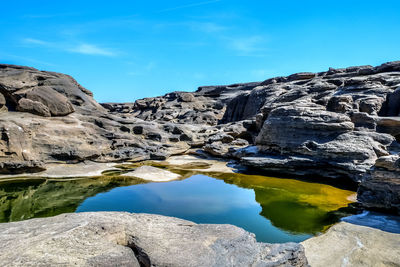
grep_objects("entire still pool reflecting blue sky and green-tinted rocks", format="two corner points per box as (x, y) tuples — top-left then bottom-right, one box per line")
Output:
(0, 173), (354, 245)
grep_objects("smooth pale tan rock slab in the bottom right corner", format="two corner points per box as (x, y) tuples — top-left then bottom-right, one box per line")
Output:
(302, 222), (400, 267)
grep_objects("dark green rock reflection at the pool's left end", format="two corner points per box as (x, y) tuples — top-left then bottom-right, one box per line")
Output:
(0, 177), (140, 222)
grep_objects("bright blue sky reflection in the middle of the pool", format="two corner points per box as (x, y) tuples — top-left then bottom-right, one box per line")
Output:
(76, 175), (309, 242)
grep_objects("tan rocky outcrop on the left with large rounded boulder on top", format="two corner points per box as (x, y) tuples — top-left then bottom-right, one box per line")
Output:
(0, 65), (212, 173)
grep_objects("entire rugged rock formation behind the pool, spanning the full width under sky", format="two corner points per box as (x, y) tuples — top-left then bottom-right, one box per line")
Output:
(0, 61), (400, 212)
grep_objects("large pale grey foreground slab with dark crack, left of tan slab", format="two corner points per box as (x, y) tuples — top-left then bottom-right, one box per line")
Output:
(0, 212), (307, 266)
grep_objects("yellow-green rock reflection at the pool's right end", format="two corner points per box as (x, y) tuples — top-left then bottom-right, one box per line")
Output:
(210, 174), (354, 234)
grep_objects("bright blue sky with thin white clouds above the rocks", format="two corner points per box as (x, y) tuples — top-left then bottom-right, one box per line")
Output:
(0, 0), (400, 102)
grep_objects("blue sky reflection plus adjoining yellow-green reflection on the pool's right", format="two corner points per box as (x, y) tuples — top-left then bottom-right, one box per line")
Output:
(77, 173), (353, 242)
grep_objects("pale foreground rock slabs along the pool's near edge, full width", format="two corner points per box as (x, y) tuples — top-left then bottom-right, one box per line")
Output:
(0, 212), (400, 267)
